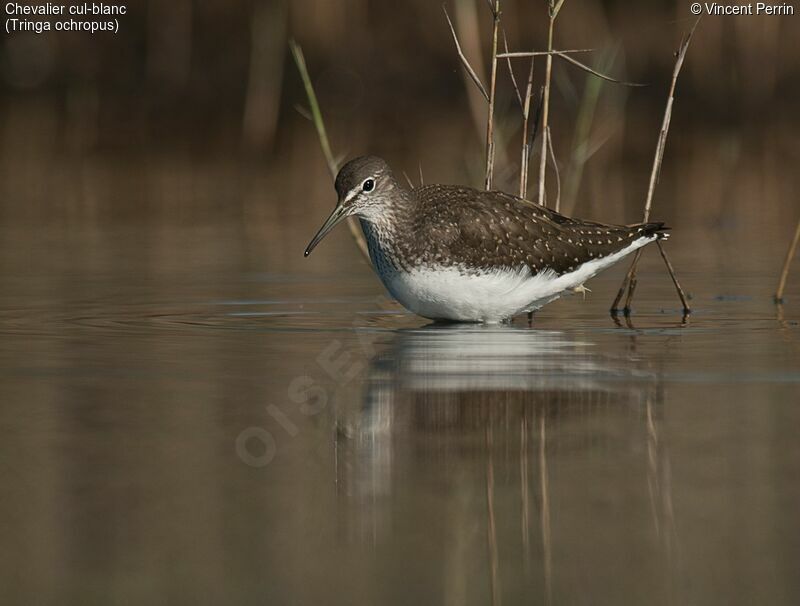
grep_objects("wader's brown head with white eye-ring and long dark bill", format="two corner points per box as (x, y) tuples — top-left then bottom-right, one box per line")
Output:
(305, 156), (400, 257)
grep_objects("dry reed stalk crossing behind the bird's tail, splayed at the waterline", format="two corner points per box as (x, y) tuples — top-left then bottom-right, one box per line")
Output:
(611, 19), (700, 315)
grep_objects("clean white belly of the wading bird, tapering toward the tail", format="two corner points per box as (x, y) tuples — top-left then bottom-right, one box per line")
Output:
(376, 236), (656, 323)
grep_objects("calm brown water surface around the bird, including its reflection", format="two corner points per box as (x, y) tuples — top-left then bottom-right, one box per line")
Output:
(0, 220), (800, 605)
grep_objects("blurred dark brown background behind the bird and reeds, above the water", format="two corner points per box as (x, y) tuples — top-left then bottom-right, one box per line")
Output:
(0, 0), (800, 278)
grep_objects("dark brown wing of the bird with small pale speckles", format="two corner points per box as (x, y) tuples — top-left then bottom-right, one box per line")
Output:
(415, 185), (665, 275)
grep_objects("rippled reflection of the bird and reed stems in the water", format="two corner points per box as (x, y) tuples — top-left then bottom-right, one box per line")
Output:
(335, 325), (669, 603)
